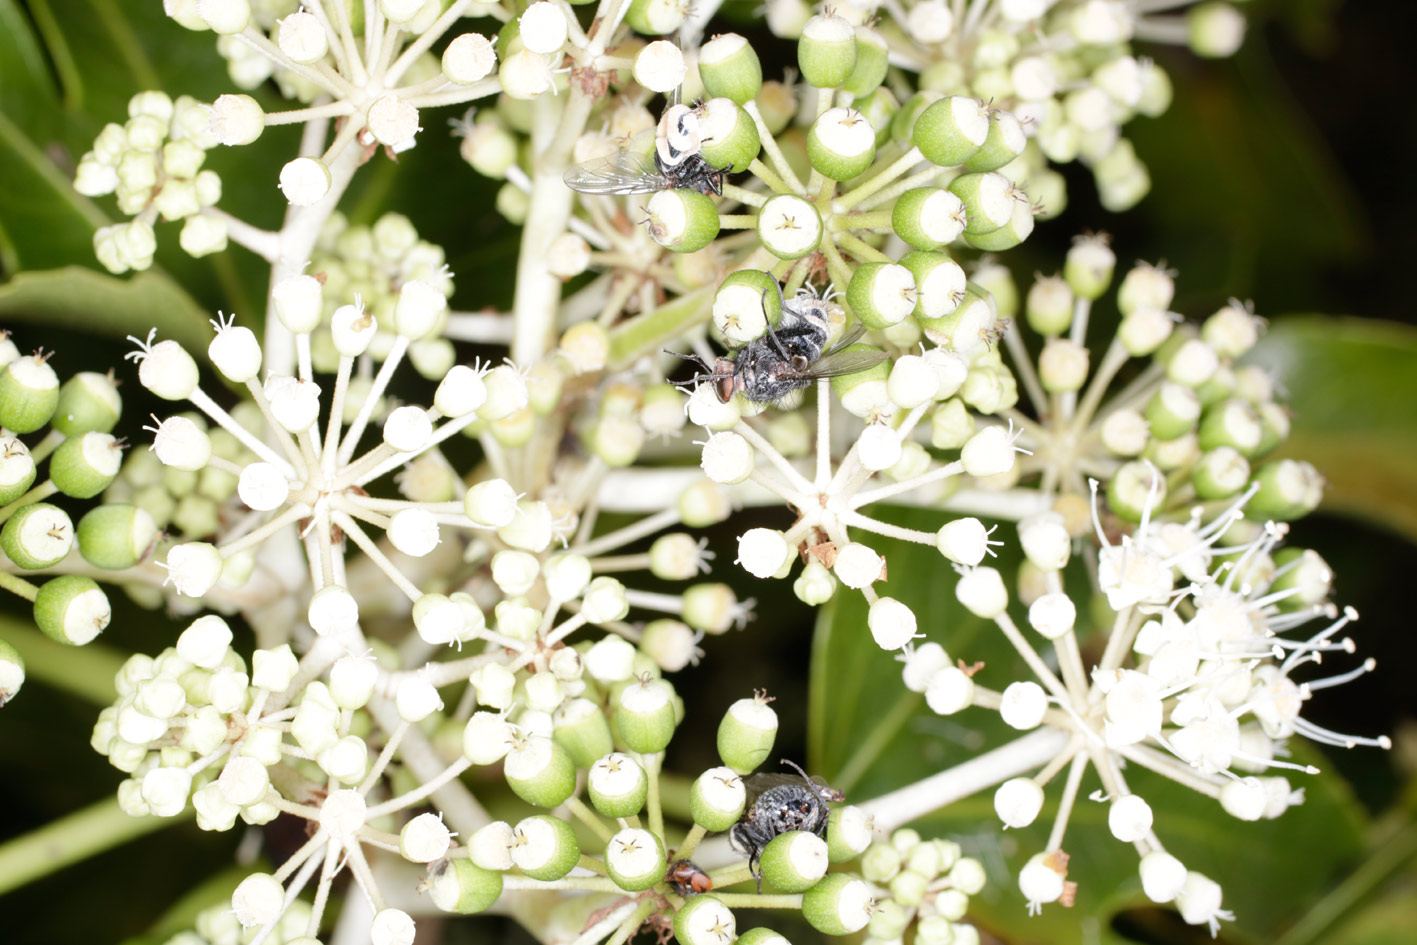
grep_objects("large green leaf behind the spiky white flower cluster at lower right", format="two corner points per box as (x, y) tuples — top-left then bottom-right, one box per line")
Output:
(808, 510), (1363, 945)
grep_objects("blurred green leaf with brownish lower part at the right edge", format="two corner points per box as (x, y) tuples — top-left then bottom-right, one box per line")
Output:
(1250, 316), (1417, 541)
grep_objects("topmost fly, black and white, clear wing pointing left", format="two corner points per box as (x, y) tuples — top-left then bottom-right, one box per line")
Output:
(564, 105), (723, 196)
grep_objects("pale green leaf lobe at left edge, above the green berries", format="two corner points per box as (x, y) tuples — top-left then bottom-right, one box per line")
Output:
(0, 266), (211, 353)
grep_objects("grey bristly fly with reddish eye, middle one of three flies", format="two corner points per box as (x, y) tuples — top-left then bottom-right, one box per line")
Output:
(666, 288), (886, 404)
